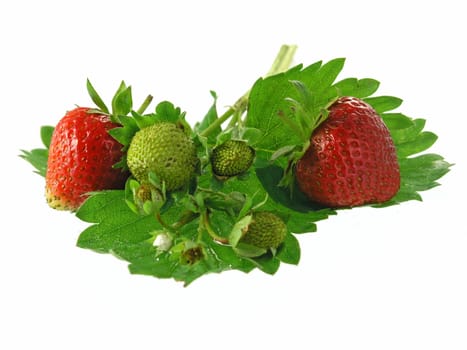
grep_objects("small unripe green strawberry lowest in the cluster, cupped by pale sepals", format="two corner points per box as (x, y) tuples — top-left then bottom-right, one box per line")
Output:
(240, 211), (287, 249)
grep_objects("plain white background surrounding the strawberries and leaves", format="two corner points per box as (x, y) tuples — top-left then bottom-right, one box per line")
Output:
(0, 0), (467, 350)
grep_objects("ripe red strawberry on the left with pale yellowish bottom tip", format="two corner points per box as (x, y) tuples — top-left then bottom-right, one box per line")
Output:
(46, 107), (128, 210)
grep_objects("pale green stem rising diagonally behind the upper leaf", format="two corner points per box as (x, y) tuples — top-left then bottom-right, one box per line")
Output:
(201, 45), (297, 137)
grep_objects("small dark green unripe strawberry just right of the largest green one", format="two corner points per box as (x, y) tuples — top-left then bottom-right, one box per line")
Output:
(211, 140), (255, 177)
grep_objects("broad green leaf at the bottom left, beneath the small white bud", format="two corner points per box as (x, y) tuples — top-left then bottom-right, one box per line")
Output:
(76, 190), (256, 285)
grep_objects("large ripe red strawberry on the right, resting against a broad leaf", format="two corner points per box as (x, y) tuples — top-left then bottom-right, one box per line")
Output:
(295, 97), (400, 207)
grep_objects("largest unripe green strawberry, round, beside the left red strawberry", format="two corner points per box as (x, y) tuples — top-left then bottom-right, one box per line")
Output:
(127, 122), (198, 191)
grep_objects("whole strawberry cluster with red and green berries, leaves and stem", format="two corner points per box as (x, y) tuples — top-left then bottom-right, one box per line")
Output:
(21, 46), (451, 285)
